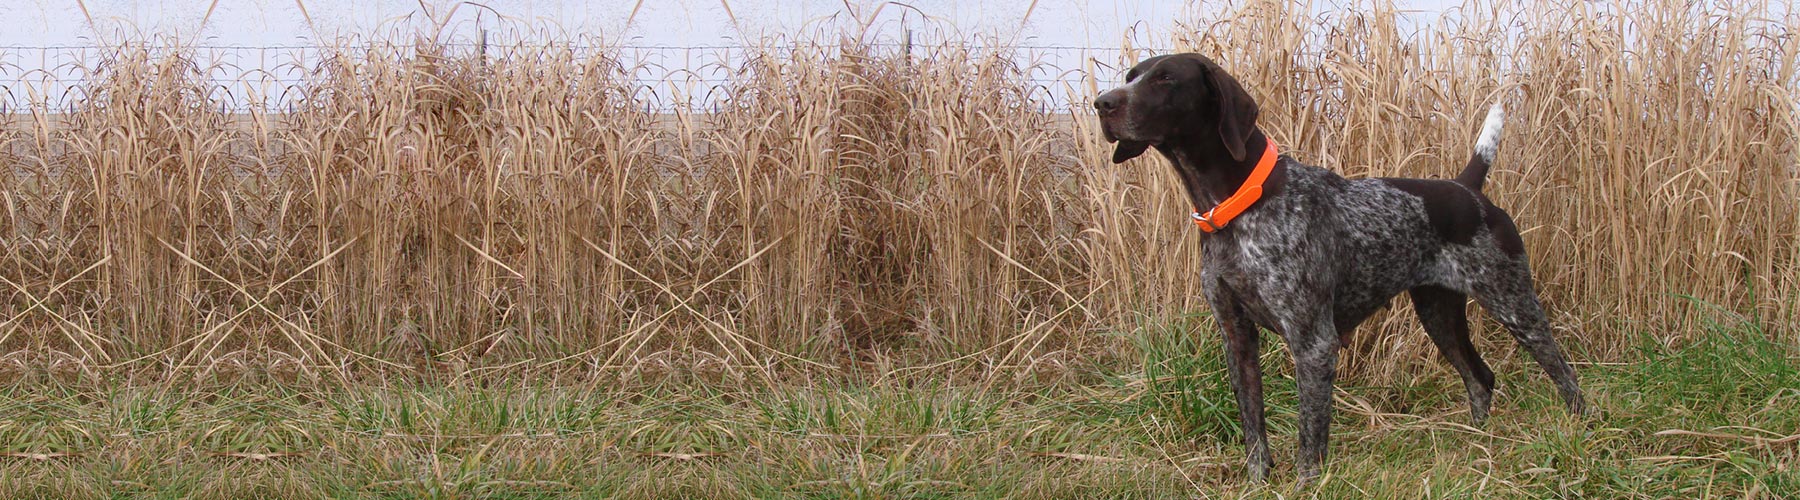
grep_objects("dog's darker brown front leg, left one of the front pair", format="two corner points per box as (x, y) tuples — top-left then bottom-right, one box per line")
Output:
(1213, 299), (1274, 482)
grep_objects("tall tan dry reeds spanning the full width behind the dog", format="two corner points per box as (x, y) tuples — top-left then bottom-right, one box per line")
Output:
(0, 2), (1800, 379)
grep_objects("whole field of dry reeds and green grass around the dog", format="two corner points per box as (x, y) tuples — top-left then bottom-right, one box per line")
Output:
(0, 0), (1800, 498)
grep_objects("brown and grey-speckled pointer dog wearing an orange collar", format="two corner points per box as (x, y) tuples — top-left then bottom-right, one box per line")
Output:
(1094, 54), (1586, 486)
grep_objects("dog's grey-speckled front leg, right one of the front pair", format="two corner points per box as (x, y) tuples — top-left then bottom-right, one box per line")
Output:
(1287, 316), (1339, 486)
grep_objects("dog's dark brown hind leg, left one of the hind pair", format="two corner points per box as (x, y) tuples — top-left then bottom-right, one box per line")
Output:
(1411, 286), (1494, 424)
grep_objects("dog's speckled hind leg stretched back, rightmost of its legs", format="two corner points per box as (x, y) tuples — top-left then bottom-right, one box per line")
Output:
(1471, 255), (1588, 415)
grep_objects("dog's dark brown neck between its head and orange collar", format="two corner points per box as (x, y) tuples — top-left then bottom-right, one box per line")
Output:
(1156, 129), (1285, 212)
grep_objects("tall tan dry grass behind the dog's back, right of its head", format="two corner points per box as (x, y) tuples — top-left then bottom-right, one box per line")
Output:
(1181, 2), (1800, 383)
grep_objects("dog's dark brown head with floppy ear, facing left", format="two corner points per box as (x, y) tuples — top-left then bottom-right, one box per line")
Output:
(1094, 54), (1256, 164)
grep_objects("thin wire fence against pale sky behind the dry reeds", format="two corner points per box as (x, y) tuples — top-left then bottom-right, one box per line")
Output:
(0, 41), (1170, 113)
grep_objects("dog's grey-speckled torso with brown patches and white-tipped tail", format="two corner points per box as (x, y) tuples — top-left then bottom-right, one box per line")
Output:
(1208, 106), (1525, 335)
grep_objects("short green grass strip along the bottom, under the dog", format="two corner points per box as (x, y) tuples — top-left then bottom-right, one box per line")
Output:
(0, 317), (1800, 498)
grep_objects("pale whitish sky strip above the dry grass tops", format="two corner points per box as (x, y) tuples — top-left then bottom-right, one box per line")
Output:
(0, 0), (1462, 106)
